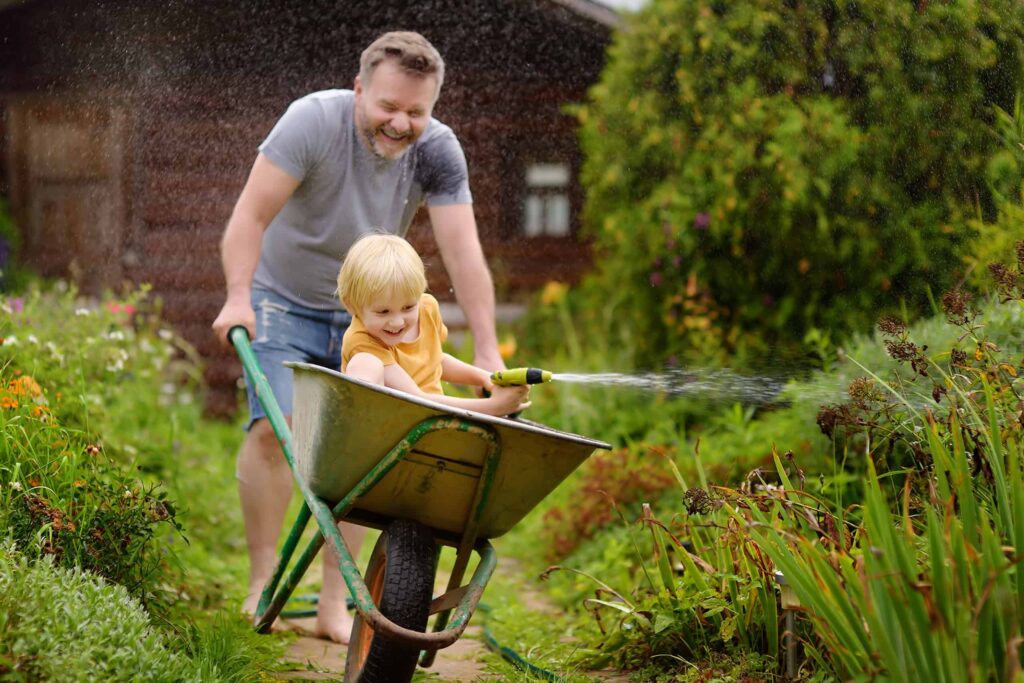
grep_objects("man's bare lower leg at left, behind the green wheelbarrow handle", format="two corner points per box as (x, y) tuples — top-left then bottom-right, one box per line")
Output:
(238, 418), (292, 614)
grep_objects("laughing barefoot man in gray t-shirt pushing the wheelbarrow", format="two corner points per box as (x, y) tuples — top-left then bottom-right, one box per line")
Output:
(213, 32), (504, 643)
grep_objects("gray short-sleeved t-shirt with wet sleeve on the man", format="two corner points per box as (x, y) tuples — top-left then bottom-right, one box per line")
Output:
(253, 90), (473, 310)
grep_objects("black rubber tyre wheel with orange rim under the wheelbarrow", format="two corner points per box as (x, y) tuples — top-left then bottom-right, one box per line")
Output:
(345, 519), (437, 683)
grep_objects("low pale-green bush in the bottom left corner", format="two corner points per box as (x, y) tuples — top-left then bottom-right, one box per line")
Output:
(0, 546), (201, 683)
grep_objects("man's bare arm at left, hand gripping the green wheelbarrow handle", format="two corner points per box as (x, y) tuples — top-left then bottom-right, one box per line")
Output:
(213, 154), (299, 344)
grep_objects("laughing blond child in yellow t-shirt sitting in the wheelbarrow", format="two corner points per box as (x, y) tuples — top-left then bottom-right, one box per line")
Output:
(338, 234), (529, 416)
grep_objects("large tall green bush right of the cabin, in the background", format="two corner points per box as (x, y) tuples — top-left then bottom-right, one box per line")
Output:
(579, 0), (1024, 365)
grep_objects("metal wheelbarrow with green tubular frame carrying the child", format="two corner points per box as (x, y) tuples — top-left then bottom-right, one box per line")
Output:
(228, 327), (610, 683)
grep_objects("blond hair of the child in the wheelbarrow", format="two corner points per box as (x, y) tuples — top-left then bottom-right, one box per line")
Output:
(338, 233), (427, 315)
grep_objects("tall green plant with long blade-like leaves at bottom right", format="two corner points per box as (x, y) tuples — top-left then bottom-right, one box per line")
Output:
(734, 252), (1024, 682)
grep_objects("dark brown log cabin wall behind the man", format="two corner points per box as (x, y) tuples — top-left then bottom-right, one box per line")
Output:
(0, 0), (609, 413)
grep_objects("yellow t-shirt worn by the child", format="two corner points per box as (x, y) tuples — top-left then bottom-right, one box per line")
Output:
(341, 294), (447, 393)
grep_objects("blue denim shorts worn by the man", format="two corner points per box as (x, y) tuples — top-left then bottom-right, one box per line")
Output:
(246, 289), (352, 431)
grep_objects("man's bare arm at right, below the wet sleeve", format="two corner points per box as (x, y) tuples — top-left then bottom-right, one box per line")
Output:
(427, 204), (505, 372)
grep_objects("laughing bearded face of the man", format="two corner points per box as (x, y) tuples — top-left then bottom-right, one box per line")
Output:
(355, 59), (437, 160)
